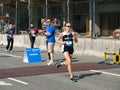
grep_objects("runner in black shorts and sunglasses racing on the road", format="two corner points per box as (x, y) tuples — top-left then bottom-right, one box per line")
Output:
(56, 23), (78, 82)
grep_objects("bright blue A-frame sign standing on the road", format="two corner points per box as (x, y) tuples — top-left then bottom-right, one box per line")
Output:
(23, 48), (42, 63)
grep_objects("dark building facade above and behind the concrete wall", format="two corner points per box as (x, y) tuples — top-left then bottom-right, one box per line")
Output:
(0, 0), (120, 37)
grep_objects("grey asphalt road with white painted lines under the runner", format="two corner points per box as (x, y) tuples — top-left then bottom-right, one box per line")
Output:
(0, 46), (120, 90)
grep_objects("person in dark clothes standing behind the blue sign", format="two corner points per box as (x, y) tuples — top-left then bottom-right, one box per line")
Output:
(27, 22), (38, 48)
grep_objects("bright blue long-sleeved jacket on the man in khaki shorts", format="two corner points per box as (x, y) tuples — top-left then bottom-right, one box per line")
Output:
(46, 25), (55, 42)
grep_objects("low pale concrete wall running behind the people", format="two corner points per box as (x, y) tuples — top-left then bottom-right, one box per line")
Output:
(0, 35), (120, 57)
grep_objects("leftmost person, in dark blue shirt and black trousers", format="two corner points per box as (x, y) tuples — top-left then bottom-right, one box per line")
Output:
(6, 24), (15, 52)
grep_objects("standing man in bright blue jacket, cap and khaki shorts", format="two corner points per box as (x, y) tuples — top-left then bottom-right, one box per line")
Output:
(44, 19), (55, 65)
